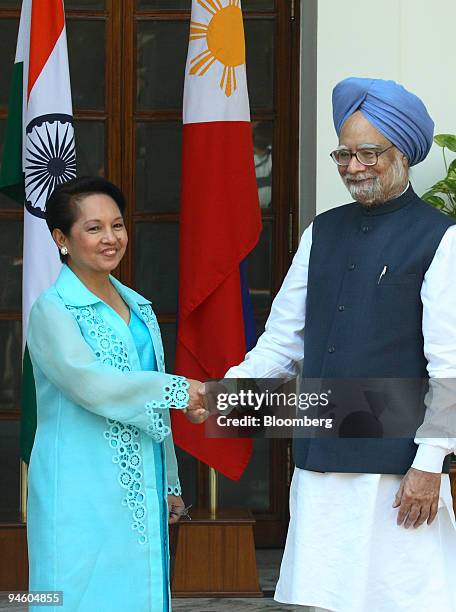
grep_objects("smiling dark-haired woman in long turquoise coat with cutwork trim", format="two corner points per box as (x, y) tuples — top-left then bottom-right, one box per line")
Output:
(27, 177), (204, 612)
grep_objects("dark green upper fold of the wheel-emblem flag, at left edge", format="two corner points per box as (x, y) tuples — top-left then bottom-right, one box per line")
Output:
(0, 62), (25, 204)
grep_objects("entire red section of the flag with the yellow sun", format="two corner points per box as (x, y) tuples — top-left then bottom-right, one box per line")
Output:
(173, 121), (261, 480)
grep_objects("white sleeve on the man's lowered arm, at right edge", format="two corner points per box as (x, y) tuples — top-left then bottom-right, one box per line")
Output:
(412, 226), (456, 473)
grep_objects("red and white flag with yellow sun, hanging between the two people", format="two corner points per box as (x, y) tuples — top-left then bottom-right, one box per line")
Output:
(173, 0), (261, 480)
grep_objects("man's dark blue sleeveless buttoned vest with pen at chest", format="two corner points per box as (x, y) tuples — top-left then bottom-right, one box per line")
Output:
(293, 187), (454, 474)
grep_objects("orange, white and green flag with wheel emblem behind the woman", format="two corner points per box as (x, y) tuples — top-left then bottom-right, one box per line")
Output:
(0, 0), (76, 463)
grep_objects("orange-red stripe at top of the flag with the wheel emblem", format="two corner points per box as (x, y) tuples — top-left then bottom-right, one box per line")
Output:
(27, 0), (65, 99)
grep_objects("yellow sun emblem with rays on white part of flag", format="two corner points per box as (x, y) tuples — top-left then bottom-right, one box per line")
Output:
(190, 0), (245, 97)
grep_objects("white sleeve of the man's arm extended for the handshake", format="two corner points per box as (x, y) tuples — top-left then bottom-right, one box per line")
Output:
(225, 225), (312, 378)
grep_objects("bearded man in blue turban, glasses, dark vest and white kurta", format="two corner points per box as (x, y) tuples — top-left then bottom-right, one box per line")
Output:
(225, 78), (456, 612)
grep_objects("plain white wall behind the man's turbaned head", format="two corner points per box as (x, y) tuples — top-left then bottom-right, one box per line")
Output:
(308, 0), (456, 219)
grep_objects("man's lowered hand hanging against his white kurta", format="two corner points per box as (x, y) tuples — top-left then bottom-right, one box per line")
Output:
(393, 468), (441, 529)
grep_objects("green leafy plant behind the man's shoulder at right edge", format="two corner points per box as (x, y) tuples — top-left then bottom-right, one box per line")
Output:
(422, 134), (456, 219)
